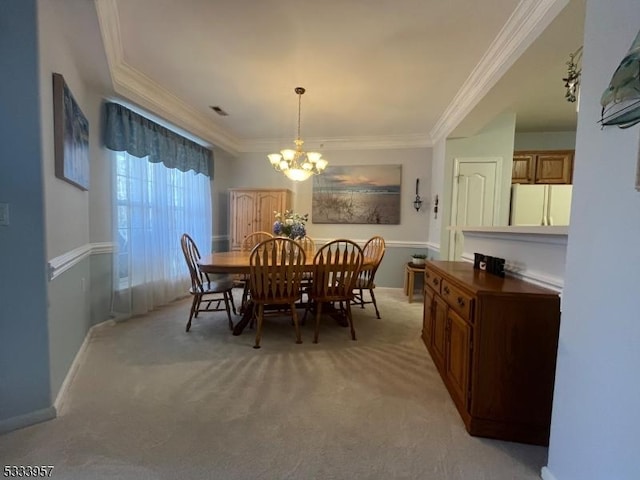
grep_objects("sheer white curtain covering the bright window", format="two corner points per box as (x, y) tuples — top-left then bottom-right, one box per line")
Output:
(112, 152), (211, 318)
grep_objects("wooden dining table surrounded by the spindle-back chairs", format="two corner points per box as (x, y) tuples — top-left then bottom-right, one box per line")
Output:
(198, 250), (375, 335)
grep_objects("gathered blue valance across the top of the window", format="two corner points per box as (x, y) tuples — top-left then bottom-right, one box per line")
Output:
(104, 102), (213, 177)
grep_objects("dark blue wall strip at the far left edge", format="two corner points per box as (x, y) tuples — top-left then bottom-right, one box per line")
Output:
(0, 0), (55, 431)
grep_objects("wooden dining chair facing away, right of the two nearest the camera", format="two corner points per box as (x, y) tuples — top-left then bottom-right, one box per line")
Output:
(305, 239), (364, 343)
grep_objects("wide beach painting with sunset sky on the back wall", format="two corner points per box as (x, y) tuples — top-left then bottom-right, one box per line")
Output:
(311, 165), (402, 225)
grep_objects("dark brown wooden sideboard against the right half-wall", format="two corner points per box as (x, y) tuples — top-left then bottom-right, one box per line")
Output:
(422, 261), (560, 445)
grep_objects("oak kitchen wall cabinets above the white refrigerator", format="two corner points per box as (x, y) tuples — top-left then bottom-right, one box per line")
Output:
(511, 150), (574, 184)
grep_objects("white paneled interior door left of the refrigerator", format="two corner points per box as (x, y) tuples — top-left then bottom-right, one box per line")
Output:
(449, 157), (502, 260)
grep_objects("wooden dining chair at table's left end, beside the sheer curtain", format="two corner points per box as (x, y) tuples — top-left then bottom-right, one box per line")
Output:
(180, 233), (236, 332)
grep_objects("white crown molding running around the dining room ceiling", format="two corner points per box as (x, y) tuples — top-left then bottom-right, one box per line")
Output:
(95, 0), (569, 156)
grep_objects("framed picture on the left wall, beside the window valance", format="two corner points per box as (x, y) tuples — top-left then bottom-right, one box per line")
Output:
(53, 73), (89, 190)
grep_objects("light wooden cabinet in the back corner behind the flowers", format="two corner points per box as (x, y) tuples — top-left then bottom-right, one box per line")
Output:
(229, 188), (291, 250)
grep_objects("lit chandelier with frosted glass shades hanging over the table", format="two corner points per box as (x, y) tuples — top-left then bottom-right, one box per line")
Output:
(267, 87), (329, 182)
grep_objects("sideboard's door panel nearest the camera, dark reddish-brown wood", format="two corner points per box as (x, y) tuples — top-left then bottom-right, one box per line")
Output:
(445, 309), (471, 409)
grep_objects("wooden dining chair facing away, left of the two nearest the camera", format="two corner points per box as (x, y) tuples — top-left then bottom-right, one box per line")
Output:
(249, 237), (306, 348)
